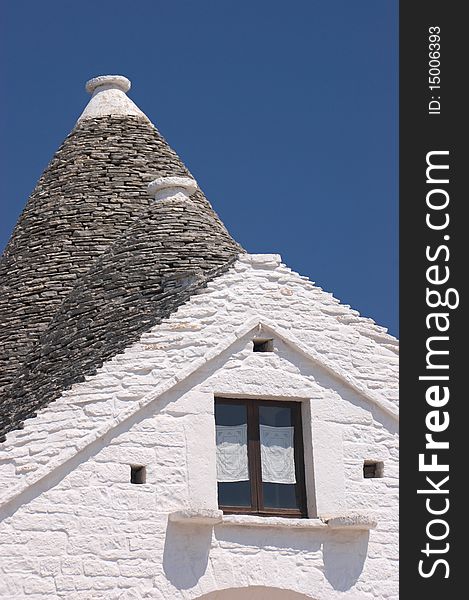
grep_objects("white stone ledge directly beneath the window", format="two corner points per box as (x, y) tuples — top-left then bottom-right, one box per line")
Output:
(169, 509), (376, 531)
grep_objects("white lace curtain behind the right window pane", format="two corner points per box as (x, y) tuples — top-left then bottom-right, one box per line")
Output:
(259, 425), (296, 483)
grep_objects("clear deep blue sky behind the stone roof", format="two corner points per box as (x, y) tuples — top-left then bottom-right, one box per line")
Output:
(0, 0), (398, 335)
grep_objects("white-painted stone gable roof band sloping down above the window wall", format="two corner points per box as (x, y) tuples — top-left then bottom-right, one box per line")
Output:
(0, 255), (397, 516)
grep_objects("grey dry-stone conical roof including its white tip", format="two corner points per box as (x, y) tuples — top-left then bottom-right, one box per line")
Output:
(0, 76), (242, 435)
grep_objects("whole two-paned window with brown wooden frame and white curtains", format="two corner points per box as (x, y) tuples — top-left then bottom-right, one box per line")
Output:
(215, 398), (306, 517)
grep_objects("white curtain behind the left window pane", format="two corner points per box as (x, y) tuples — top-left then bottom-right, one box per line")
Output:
(216, 424), (249, 482)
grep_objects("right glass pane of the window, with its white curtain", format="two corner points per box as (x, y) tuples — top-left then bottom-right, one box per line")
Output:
(259, 405), (298, 508)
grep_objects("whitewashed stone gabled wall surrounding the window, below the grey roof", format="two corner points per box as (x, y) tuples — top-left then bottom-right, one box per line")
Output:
(0, 255), (398, 600)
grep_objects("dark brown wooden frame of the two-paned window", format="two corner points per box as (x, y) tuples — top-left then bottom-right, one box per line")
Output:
(215, 397), (308, 518)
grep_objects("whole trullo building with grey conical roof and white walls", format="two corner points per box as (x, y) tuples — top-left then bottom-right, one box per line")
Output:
(0, 76), (398, 600)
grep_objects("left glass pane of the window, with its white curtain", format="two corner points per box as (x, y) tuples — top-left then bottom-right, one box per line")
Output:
(215, 403), (251, 506)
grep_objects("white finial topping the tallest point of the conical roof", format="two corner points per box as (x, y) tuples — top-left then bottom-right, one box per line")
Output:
(78, 75), (149, 121)
